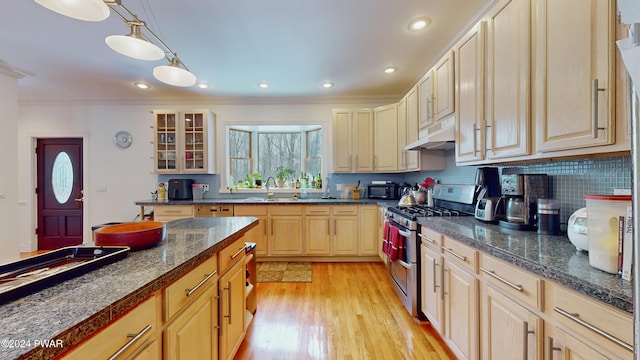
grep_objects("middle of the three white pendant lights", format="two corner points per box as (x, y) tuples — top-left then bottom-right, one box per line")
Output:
(104, 23), (164, 60)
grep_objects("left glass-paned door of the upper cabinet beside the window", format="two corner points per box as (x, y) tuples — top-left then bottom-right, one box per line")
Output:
(153, 110), (180, 173)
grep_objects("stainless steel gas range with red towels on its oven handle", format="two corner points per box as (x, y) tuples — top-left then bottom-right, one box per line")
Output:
(385, 184), (478, 319)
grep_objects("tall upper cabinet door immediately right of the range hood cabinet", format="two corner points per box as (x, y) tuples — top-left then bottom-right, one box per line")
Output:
(454, 22), (485, 163)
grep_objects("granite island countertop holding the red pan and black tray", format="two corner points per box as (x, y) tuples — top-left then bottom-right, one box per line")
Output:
(0, 217), (257, 359)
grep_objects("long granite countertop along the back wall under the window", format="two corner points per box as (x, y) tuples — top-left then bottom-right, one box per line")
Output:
(135, 195), (398, 206)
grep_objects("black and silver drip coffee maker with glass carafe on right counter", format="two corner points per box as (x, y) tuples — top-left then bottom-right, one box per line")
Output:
(498, 174), (549, 230)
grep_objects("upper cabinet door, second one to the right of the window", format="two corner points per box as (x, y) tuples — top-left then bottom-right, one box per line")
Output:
(349, 109), (374, 172)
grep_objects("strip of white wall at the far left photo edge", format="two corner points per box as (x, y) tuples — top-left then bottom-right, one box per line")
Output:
(0, 74), (20, 264)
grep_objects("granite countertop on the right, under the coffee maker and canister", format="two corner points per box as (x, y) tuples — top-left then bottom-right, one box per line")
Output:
(418, 216), (633, 313)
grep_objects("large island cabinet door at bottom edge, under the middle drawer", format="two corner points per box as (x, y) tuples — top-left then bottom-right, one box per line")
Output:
(164, 282), (218, 360)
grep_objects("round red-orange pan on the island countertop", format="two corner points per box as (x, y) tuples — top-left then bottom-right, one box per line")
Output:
(93, 221), (167, 250)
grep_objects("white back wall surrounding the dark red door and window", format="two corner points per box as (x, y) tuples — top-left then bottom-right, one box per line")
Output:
(18, 98), (383, 251)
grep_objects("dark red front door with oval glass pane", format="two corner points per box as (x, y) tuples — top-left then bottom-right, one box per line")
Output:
(36, 138), (84, 250)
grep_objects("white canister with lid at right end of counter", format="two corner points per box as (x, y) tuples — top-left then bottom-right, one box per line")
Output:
(584, 195), (631, 274)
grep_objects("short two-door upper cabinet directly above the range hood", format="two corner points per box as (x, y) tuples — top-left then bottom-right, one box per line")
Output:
(418, 51), (455, 138)
